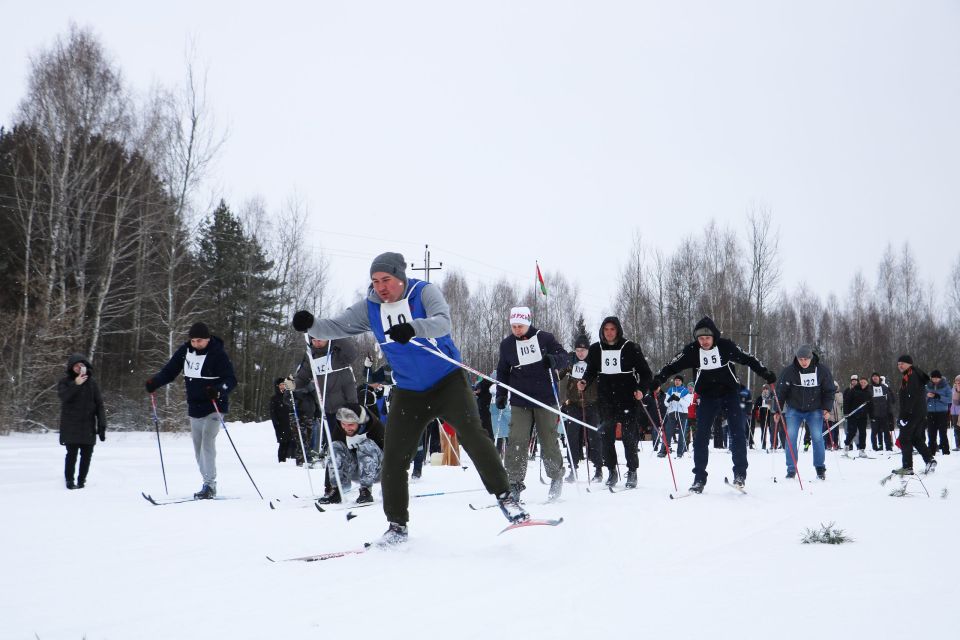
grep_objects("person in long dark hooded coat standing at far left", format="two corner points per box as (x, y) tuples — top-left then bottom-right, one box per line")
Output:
(57, 354), (107, 489)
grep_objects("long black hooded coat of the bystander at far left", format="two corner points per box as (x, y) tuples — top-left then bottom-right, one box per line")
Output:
(57, 355), (107, 445)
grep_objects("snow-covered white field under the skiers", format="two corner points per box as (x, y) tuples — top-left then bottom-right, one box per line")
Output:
(0, 423), (960, 640)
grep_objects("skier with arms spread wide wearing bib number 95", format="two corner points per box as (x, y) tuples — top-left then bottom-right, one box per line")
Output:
(650, 316), (777, 493)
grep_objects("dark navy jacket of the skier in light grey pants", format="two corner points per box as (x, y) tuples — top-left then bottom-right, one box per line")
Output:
(153, 336), (237, 418)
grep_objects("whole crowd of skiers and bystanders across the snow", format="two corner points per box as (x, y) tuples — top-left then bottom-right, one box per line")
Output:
(58, 252), (960, 545)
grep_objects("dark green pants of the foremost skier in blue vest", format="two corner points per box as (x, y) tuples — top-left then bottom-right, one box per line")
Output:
(380, 371), (510, 524)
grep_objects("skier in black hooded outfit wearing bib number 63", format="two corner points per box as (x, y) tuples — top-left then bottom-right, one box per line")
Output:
(577, 316), (650, 489)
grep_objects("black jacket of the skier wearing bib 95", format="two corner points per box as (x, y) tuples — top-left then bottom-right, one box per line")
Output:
(653, 316), (774, 398)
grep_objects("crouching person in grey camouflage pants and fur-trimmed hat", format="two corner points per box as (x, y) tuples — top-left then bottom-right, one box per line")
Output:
(319, 402), (383, 504)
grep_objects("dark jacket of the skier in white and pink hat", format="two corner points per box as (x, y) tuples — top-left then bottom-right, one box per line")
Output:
(496, 325), (567, 407)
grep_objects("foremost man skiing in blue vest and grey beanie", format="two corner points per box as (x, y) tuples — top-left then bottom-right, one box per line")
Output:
(293, 252), (530, 546)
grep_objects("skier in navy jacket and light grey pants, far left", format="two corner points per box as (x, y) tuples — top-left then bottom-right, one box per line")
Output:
(143, 322), (237, 500)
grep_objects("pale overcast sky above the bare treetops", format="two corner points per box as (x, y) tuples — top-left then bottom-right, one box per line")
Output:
(0, 0), (960, 328)
